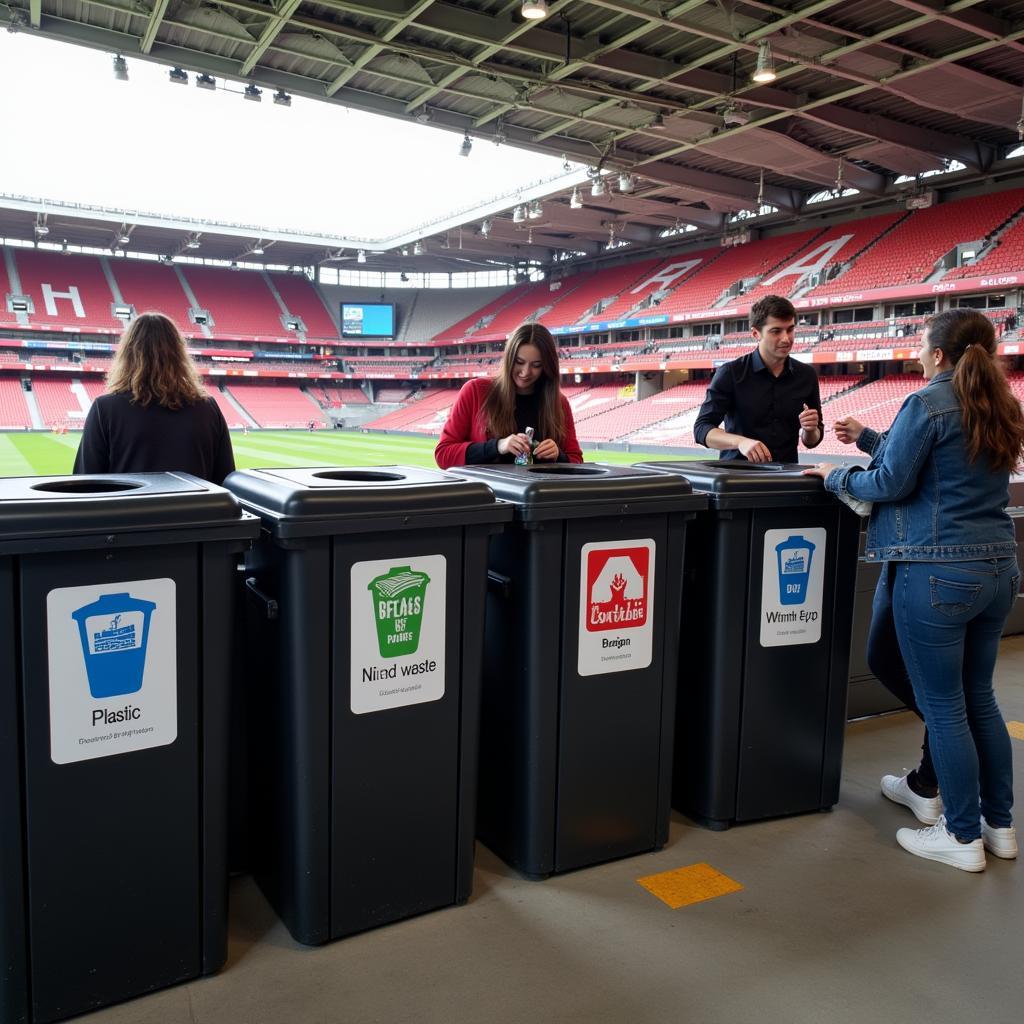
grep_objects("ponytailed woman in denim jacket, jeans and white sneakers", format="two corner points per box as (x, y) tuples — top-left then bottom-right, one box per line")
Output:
(807, 309), (1024, 871)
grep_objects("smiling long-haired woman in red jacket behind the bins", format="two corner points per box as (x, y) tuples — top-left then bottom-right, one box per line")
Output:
(434, 324), (583, 469)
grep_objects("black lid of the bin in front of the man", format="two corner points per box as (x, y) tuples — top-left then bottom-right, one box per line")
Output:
(640, 459), (836, 509)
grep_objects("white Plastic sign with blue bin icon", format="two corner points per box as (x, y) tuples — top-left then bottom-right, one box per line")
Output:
(46, 579), (178, 765)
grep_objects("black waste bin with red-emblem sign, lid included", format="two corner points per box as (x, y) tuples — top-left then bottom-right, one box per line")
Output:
(457, 463), (707, 878)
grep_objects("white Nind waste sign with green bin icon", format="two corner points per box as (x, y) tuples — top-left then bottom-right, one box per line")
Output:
(349, 555), (446, 715)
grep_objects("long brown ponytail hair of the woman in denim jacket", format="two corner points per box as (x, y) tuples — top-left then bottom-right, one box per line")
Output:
(925, 308), (1024, 472)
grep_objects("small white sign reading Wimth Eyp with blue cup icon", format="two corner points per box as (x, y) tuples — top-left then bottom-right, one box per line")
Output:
(761, 526), (827, 647)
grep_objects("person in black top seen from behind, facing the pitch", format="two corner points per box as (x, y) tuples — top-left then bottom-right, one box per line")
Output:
(74, 313), (234, 483)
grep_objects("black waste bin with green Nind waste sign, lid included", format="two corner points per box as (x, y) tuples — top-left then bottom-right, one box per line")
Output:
(225, 466), (511, 944)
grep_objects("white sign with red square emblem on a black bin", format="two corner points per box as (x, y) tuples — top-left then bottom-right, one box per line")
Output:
(578, 540), (654, 676)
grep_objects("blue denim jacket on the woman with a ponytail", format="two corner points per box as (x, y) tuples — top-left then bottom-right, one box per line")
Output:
(825, 371), (1017, 562)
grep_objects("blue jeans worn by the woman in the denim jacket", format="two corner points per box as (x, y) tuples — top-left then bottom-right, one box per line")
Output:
(889, 558), (1020, 841)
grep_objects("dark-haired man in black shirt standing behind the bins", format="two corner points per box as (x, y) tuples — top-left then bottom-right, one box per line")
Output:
(693, 295), (821, 463)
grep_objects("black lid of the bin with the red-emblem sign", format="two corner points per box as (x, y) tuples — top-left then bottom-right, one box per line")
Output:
(452, 462), (708, 522)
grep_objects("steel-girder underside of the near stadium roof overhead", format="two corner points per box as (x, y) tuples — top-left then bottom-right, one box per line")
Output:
(0, 0), (1024, 271)
